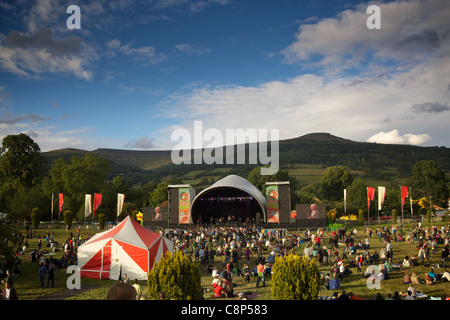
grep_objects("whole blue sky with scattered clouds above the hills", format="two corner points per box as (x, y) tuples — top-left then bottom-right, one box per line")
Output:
(0, 0), (450, 151)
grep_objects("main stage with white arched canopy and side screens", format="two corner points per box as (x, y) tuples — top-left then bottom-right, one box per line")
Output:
(142, 175), (327, 229)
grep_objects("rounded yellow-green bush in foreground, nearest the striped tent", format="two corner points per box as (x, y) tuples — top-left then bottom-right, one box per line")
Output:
(147, 251), (202, 300)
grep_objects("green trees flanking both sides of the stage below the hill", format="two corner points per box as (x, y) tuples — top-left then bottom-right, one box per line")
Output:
(0, 133), (449, 221)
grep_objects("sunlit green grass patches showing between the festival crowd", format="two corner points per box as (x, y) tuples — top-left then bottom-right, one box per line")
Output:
(2, 224), (450, 300)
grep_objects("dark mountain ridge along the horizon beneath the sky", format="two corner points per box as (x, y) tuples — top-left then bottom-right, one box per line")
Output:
(42, 132), (450, 183)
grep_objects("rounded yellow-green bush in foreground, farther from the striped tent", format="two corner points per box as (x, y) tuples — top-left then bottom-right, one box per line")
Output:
(270, 254), (320, 300)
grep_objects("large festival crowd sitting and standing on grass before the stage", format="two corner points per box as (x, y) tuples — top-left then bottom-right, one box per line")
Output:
(0, 220), (450, 300)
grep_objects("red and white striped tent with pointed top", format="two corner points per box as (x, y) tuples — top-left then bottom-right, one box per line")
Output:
(77, 216), (173, 280)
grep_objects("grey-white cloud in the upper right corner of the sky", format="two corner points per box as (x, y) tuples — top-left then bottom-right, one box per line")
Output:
(282, 0), (450, 68)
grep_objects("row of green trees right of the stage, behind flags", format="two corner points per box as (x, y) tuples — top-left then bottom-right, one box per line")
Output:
(297, 160), (449, 217)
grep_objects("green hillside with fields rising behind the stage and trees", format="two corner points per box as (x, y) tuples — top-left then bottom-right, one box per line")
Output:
(43, 133), (450, 188)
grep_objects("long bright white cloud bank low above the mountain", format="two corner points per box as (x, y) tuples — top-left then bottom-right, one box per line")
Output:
(161, 51), (450, 143)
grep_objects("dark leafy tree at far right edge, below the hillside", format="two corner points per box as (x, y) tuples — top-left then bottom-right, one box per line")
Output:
(409, 160), (449, 206)
